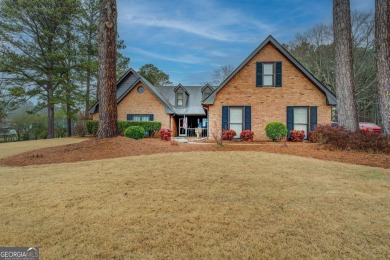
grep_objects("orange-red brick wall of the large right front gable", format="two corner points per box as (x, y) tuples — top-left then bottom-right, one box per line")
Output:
(209, 43), (331, 140)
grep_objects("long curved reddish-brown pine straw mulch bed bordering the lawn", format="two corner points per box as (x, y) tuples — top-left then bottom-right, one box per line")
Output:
(0, 136), (390, 169)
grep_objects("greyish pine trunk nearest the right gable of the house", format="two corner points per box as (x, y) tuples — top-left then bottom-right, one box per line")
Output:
(333, 0), (359, 131)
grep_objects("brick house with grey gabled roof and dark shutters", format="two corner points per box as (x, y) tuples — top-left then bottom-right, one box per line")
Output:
(89, 36), (336, 140)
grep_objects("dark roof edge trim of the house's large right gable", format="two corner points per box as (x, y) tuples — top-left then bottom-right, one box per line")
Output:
(203, 35), (336, 105)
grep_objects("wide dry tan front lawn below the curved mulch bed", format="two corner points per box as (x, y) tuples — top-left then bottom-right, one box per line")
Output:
(0, 152), (390, 259)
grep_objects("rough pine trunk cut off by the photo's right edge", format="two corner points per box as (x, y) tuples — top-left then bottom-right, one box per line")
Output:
(375, 0), (390, 136)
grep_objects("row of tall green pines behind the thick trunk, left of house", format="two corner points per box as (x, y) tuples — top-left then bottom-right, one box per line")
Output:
(0, 0), (130, 138)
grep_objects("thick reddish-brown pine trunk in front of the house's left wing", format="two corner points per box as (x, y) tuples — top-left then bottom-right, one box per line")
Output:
(96, 0), (118, 139)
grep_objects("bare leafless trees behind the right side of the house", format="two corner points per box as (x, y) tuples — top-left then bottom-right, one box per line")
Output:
(284, 9), (381, 123)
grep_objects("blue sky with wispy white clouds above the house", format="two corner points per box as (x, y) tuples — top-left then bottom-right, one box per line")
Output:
(117, 0), (374, 85)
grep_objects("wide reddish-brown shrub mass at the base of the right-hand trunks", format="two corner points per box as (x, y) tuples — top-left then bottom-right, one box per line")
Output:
(310, 125), (390, 154)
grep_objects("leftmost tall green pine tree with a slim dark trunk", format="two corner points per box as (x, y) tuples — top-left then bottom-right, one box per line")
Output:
(0, 0), (78, 138)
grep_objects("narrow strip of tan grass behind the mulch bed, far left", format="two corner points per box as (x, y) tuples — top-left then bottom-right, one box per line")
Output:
(0, 137), (88, 159)
